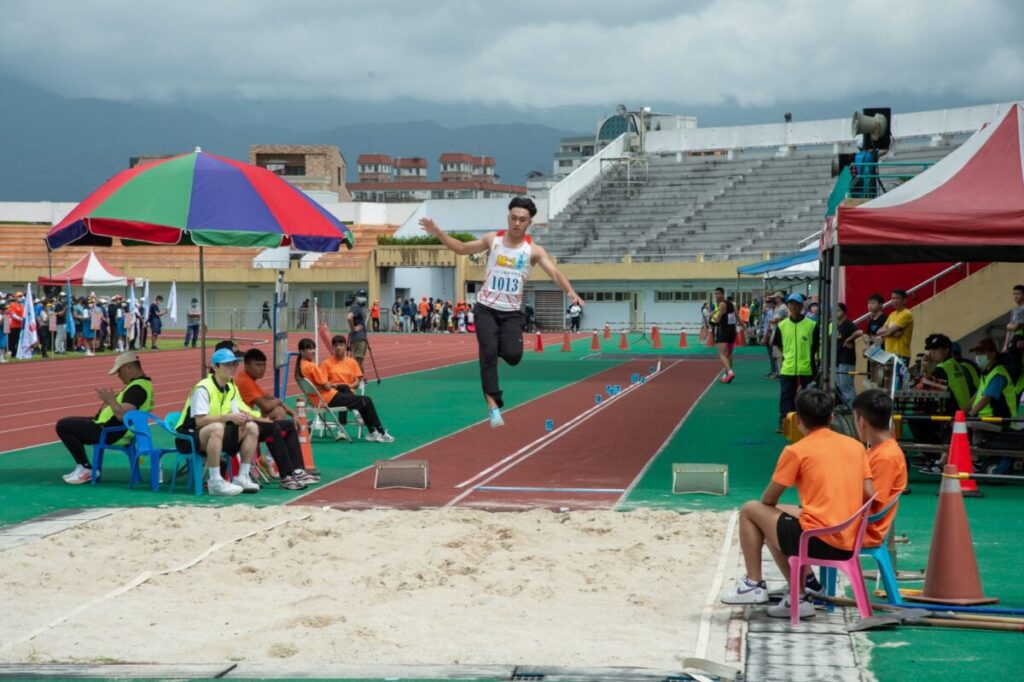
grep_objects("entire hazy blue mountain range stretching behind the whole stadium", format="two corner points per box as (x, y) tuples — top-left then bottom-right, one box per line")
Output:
(0, 74), (995, 202)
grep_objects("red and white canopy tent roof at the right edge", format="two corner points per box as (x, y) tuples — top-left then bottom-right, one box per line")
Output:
(821, 103), (1024, 265)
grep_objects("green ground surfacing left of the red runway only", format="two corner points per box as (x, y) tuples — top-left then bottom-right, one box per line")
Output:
(0, 342), (615, 524)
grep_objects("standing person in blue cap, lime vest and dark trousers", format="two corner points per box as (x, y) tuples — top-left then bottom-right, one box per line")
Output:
(772, 294), (820, 433)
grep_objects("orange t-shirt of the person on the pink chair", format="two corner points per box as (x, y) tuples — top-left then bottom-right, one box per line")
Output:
(771, 428), (871, 550)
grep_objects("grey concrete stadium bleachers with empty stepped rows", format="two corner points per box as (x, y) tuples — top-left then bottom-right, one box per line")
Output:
(537, 141), (954, 263)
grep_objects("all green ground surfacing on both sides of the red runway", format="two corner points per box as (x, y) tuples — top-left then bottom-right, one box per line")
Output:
(0, 346), (1024, 681)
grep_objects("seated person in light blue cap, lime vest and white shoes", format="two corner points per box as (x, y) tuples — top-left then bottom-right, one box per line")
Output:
(175, 348), (259, 497)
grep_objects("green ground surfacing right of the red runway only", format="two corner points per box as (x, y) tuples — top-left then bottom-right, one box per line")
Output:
(623, 361), (1024, 682)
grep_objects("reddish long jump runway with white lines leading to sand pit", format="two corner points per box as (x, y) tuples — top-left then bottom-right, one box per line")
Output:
(292, 360), (721, 510)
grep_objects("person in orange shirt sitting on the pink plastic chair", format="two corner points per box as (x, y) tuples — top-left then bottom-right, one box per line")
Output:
(721, 388), (874, 617)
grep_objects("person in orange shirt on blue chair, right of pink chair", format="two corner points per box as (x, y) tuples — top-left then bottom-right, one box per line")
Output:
(853, 388), (906, 547)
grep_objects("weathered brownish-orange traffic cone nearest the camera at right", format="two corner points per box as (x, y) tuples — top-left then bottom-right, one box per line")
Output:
(905, 464), (998, 605)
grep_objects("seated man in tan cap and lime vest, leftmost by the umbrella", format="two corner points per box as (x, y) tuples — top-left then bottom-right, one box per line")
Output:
(56, 352), (153, 485)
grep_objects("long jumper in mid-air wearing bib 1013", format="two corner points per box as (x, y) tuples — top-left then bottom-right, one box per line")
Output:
(420, 197), (584, 427)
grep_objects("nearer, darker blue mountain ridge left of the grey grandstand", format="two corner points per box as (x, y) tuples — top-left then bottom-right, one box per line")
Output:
(0, 76), (579, 202)
